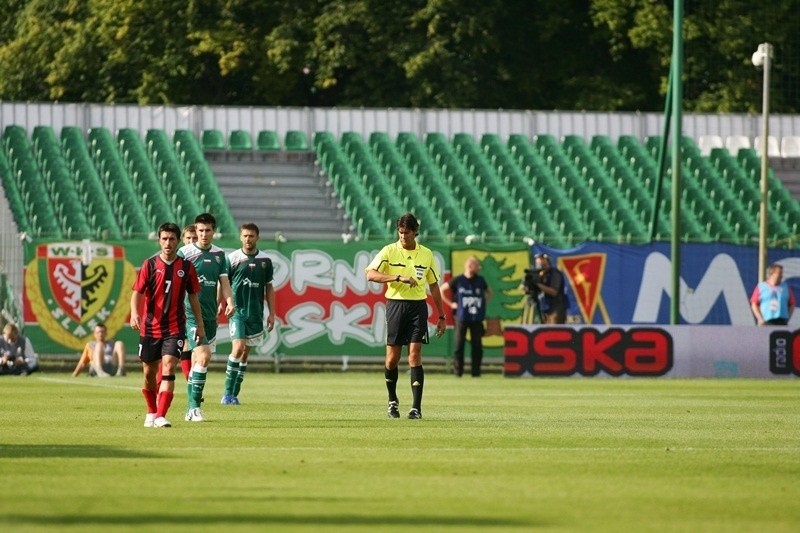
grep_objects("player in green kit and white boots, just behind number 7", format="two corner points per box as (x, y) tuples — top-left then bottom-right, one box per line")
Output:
(178, 213), (235, 422)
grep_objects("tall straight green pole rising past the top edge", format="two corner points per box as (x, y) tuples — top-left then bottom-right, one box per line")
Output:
(669, 0), (683, 325)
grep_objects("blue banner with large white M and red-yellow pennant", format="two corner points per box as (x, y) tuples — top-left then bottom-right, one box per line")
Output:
(532, 243), (800, 329)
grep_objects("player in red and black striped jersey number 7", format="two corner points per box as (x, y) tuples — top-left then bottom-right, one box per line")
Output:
(131, 222), (205, 428)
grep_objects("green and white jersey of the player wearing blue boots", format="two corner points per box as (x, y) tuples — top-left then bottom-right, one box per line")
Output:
(228, 248), (273, 321)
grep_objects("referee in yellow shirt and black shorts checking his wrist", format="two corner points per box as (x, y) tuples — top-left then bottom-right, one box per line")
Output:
(364, 213), (445, 419)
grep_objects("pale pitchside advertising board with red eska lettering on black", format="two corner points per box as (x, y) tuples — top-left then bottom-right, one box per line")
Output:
(503, 325), (800, 378)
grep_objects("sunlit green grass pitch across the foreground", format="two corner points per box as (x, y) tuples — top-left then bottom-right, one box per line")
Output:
(0, 369), (800, 532)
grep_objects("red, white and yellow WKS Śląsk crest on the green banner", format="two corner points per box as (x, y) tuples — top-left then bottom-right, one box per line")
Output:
(25, 241), (136, 350)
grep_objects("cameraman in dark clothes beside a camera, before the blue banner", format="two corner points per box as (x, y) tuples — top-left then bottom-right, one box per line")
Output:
(522, 254), (567, 324)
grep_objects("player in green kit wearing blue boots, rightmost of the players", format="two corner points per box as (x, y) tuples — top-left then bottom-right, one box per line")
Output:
(221, 223), (275, 405)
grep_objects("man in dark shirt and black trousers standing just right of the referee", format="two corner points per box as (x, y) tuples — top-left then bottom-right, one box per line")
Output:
(440, 256), (492, 377)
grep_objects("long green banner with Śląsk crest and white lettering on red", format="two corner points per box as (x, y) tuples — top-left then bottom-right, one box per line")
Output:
(24, 240), (529, 358)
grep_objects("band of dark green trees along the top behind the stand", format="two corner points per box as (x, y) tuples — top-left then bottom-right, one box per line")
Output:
(0, 0), (800, 112)
